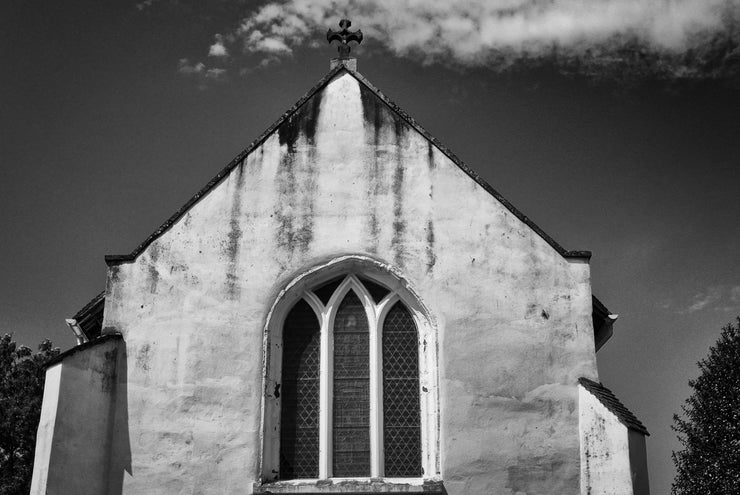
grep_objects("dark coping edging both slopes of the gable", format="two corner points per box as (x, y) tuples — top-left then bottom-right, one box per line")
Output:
(105, 64), (591, 265)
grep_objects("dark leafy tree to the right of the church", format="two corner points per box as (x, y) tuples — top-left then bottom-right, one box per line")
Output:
(671, 317), (740, 495)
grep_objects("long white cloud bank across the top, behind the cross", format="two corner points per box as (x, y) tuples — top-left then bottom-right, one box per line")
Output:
(211, 0), (740, 77)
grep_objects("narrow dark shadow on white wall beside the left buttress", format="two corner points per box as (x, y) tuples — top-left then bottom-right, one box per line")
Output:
(107, 339), (133, 495)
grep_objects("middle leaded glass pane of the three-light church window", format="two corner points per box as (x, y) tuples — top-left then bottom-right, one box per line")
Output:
(332, 291), (370, 477)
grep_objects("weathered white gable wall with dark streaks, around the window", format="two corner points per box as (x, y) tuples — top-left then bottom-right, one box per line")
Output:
(103, 73), (597, 495)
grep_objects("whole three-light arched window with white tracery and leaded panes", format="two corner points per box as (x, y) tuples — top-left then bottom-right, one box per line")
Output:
(263, 274), (429, 480)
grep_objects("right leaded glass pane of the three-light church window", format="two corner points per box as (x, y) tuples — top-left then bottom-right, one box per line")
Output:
(383, 302), (422, 477)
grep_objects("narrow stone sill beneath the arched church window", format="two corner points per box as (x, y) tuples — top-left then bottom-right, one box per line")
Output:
(252, 479), (447, 495)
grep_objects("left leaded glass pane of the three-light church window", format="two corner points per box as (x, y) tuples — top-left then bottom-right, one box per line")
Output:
(280, 299), (321, 479)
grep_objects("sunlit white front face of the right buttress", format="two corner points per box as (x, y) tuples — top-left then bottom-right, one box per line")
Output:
(578, 385), (639, 495)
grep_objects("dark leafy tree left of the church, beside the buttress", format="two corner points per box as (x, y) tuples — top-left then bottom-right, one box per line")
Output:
(0, 334), (59, 495)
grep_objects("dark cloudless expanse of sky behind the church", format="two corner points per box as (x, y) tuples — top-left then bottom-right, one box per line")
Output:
(0, 0), (740, 494)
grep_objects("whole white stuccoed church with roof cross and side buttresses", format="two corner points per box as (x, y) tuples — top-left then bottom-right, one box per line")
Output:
(32, 21), (649, 495)
